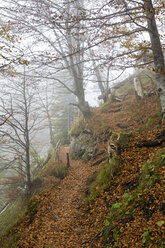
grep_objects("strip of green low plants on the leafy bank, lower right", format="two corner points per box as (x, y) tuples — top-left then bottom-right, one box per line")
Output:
(103, 149), (165, 248)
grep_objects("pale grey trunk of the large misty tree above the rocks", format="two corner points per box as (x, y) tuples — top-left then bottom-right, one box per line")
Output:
(65, 0), (91, 119)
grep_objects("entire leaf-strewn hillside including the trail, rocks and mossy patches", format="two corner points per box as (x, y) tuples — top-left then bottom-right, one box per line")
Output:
(1, 80), (165, 248)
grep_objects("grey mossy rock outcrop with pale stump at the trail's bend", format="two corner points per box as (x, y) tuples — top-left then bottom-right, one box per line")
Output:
(70, 122), (130, 166)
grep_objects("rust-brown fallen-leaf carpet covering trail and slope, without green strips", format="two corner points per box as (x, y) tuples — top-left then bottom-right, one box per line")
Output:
(1, 94), (165, 248)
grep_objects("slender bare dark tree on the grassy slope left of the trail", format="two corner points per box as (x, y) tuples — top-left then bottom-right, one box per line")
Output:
(0, 67), (39, 195)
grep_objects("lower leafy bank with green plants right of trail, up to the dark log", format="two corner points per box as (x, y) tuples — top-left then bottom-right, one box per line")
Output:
(78, 130), (165, 247)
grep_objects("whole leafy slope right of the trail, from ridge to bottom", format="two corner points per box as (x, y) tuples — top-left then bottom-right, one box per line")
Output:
(67, 92), (165, 247)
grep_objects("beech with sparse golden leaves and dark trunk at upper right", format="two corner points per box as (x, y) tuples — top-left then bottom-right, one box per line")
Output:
(86, 0), (165, 112)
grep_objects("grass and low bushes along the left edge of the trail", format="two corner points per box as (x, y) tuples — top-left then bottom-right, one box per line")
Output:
(0, 152), (67, 248)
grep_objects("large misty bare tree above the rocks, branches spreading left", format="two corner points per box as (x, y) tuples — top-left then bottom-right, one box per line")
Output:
(0, 0), (91, 118)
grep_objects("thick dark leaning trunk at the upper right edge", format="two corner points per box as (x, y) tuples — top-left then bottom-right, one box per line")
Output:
(144, 0), (165, 114)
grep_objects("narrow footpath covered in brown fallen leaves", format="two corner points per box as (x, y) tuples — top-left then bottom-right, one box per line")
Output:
(18, 149), (97, 248)
